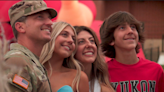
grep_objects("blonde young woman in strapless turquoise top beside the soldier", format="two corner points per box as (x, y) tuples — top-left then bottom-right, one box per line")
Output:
(40, 22), (89, 92)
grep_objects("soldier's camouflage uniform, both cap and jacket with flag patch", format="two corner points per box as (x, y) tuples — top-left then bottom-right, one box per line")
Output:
(5, 0), (57, 92)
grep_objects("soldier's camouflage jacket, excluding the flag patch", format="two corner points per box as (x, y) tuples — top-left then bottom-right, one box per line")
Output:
(5, 43), (52, 92)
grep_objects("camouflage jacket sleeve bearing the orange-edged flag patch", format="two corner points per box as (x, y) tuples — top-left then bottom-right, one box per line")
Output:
(6, 56), (35, 92)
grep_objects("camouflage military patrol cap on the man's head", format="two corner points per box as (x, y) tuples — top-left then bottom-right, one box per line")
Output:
(9, 0), (57, 26)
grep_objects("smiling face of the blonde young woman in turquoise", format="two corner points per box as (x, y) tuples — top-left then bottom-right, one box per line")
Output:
(54, 26), (75, 58)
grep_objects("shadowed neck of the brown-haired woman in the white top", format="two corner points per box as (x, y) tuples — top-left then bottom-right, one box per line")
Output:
(83, 63), (92, 81)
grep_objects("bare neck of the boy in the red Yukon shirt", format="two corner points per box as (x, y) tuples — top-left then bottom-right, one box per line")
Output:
(115, 50), (139, 65)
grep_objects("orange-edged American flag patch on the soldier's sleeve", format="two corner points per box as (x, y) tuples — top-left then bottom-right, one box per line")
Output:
(13, 74), (29, 89)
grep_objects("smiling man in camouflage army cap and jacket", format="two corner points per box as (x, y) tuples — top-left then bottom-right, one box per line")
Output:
(5, 1), (57, 92)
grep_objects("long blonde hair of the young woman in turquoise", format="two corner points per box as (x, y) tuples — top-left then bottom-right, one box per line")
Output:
(39, 22), (81, 92)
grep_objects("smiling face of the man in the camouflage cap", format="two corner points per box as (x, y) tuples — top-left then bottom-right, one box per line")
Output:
(24, 11), (52, 43)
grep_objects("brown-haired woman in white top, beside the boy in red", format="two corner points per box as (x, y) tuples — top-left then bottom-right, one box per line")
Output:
(74, 26), (114, 92)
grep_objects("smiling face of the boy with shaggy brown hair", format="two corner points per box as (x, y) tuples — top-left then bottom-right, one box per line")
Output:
(110, 23), (138, 50)
